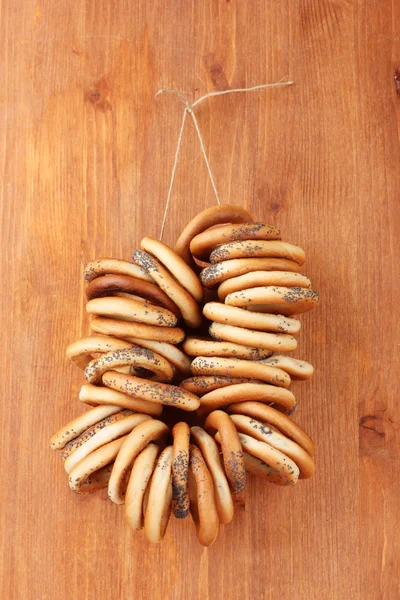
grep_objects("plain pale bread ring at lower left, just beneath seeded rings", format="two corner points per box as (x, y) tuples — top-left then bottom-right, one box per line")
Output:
(64, 414), (151, 473)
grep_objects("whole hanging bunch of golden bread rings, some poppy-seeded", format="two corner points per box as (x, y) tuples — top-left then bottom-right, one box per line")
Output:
(50, 205), (319, 546)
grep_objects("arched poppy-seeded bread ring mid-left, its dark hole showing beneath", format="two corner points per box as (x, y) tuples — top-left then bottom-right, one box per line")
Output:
(85, 346), (174, 384)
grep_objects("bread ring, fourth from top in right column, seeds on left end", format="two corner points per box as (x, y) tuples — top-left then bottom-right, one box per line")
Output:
(200, 258), (300, 288)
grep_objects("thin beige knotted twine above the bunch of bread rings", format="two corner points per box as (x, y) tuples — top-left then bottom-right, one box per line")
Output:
(155, 80), (294, 241)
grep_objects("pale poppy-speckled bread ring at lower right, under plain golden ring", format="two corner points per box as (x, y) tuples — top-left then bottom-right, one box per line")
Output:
(231, 414), (315, 479)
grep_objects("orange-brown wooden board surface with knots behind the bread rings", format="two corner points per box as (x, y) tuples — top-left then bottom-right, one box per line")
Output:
(0, 0), (400, 600)
